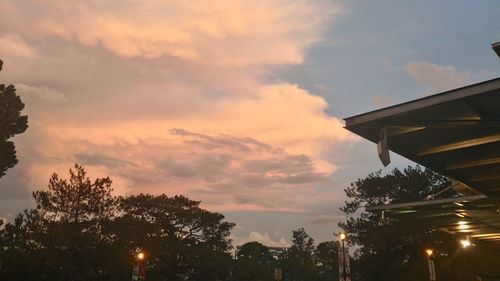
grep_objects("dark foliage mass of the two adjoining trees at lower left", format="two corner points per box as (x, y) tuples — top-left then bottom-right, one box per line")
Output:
(0, 165), (234, 281)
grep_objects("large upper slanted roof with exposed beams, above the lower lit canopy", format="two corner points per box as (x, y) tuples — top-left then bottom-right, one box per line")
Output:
(345, 78), (500, 196)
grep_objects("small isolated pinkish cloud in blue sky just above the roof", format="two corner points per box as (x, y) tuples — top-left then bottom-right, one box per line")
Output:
(405, 62), (469, 92)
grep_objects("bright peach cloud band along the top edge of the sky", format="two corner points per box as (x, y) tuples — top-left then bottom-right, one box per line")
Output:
(2, 0), (341, 65)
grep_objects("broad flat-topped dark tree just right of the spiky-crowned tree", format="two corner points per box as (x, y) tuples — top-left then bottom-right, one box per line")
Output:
(108, 194), (234, 280)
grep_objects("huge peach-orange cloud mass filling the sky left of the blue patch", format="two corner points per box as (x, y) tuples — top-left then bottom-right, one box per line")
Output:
(0, 0), (357, 244)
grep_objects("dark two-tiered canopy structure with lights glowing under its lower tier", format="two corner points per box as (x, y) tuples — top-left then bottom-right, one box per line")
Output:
(345, 78), (500, 243)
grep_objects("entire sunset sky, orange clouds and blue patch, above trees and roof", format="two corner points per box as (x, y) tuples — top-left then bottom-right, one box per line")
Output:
(0, 0), (500, 246)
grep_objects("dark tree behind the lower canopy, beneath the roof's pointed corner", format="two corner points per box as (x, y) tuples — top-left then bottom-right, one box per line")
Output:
(339, 166), (498, 281)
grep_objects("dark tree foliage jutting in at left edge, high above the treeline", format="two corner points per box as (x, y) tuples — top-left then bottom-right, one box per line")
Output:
(0, 60), (28, 177)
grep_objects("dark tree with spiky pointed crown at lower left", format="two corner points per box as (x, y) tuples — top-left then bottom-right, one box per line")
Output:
(0, 164), (117, 280)
